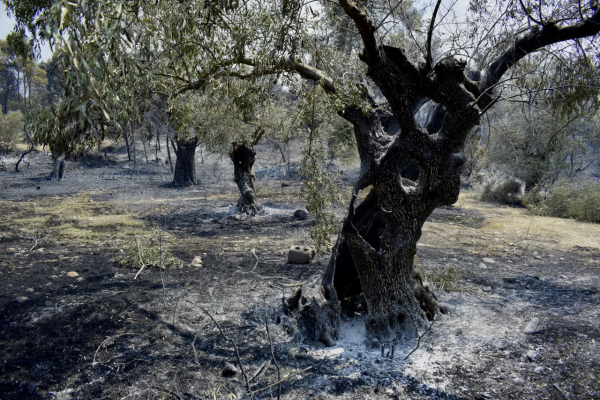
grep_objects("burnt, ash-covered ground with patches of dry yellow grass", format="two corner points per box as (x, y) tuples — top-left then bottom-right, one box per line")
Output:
(0, 148), (600, 399)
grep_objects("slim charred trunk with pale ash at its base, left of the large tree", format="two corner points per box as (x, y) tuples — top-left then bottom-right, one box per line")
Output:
(229, 142), (262, 215)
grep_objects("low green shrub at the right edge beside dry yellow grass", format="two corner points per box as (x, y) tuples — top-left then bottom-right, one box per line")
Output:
(523, 179), (600, 223)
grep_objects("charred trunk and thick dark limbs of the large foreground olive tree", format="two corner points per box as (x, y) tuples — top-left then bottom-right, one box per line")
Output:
(287, 0), (600, 344)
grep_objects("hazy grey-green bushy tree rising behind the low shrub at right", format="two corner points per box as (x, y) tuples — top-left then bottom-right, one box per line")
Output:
(484, 103), (600, 191)
